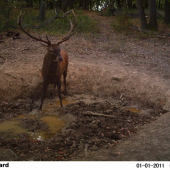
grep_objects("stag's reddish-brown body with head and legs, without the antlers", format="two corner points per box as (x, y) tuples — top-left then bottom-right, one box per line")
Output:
(39, 48), (68, 110)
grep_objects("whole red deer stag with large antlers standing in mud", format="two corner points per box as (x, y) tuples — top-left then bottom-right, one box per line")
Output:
(18, 10), (77, 110)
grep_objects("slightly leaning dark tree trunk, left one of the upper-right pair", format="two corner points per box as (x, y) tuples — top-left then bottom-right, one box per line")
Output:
(136, 0), (148, 30)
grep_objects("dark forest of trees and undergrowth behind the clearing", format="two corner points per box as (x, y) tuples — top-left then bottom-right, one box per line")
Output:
(0, 0), (170, 33)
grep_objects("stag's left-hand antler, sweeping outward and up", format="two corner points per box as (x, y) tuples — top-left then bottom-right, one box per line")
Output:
(18, 11), (51, 45)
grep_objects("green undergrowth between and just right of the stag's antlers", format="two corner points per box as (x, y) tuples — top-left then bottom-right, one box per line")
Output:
(16, 9), (99, 34)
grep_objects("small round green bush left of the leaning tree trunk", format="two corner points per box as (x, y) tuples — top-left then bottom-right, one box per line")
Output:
(111, 12), (132, 32)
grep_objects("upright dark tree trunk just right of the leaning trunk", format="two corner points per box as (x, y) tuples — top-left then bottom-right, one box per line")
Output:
(149, 0), (158, 30)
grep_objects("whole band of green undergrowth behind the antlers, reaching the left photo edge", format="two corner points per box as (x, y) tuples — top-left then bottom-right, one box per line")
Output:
(0, 8), (99, 35)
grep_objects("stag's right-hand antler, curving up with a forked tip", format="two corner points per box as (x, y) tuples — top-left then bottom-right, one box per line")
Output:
(57, 10), (77, 45)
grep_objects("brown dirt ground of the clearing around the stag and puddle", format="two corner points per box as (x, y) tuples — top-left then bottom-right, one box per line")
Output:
(0, 12), (170, 161)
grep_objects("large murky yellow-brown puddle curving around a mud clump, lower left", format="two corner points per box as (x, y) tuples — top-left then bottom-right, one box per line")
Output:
(0, 115), (65, 140)
